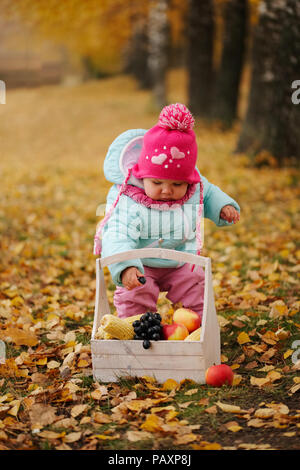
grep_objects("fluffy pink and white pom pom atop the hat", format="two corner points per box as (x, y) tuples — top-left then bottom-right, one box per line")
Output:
(158, 103), (195, 131)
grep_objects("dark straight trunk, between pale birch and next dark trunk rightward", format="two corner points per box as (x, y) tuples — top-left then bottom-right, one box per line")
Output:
(187, 0), (214, 118)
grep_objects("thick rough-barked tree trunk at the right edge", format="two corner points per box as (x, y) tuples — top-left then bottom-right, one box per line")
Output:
(236, 0), (300, 164)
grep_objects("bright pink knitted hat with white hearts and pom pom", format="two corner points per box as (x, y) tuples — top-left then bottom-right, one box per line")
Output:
(132, 103), (200, 184)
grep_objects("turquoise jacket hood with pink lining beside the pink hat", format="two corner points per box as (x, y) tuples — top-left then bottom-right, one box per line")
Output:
(103, 129), (147, 188)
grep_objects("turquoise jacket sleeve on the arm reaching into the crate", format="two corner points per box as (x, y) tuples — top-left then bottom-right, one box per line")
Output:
(101, 192), (144, 286)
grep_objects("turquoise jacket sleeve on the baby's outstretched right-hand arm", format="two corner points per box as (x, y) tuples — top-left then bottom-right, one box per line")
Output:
(201, 176), (240, 227)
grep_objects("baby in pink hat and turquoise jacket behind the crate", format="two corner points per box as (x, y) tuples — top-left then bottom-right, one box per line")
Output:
(94, 103), (240, 317)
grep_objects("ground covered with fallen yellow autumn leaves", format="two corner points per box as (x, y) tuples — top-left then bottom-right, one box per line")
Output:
(0, 72), (300, 450)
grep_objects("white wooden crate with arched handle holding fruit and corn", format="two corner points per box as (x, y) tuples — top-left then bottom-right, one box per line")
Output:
(91, 248), (220, 383)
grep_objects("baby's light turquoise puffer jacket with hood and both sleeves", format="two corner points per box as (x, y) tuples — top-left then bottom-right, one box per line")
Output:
(101, 129), (240, 286)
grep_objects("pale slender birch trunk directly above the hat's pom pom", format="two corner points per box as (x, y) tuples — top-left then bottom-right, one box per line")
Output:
(148, 0), (169, 109)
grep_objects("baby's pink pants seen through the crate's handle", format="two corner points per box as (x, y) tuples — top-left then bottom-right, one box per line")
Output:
(114, 264), (204, 318)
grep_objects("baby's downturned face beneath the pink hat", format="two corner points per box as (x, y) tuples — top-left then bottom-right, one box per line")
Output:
(143, 178), (188, 201)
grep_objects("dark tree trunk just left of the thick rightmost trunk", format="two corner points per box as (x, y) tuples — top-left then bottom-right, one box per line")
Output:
(212, 0), (248, 128)
